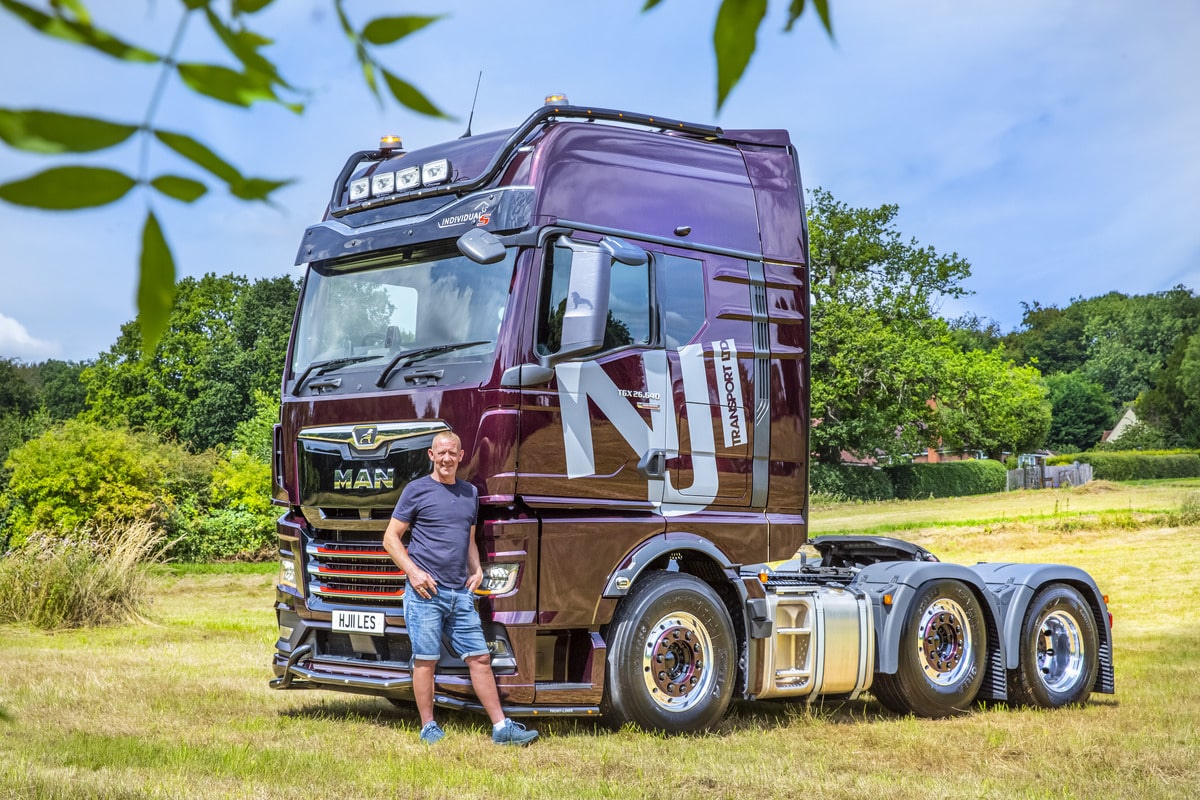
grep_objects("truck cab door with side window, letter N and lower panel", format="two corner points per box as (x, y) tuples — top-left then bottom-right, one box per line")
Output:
(516, 234), (676, 627)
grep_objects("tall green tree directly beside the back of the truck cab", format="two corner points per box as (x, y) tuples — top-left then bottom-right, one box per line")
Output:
(808, 188), (971, 463)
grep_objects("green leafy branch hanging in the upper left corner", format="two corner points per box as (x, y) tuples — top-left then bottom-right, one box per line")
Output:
(0, 0), (445, 354)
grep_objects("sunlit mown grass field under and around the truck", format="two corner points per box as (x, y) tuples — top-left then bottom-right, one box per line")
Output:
(0, 481), (1200, 800)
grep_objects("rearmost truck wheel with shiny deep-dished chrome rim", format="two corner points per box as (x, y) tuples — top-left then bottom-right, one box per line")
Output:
(1008, 583), (1100, 709)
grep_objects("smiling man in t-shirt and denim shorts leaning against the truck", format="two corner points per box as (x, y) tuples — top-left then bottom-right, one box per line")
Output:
(383, 432), (538, 745)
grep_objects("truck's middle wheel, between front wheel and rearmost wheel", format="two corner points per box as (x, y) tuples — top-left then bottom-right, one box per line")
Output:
(872, 581), (988, 717)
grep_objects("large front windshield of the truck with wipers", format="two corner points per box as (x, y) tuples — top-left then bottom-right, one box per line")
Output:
(292, 249), (515, 375)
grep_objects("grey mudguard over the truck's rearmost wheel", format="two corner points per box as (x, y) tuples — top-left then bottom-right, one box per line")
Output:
(968, 564), (1115, 694)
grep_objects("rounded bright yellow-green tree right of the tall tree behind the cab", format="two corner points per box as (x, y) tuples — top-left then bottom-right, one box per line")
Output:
(936, 350), (1050, 459)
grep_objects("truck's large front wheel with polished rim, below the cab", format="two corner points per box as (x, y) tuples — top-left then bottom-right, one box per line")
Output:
(601, 572), (737, 732)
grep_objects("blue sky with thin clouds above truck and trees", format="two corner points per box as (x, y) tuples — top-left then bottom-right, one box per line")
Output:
(0, 0), (1200, 361)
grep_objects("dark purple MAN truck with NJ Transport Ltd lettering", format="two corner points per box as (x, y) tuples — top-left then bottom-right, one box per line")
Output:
(271, 104), (1114, 730)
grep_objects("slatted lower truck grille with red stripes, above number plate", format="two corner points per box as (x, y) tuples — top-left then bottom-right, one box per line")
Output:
(305, 530), (407, 608)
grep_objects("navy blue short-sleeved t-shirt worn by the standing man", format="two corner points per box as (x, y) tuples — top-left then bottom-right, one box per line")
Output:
(391, 475), (479, 589)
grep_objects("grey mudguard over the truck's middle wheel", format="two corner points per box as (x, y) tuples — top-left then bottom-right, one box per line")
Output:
(854, 561), (1020, 699)
